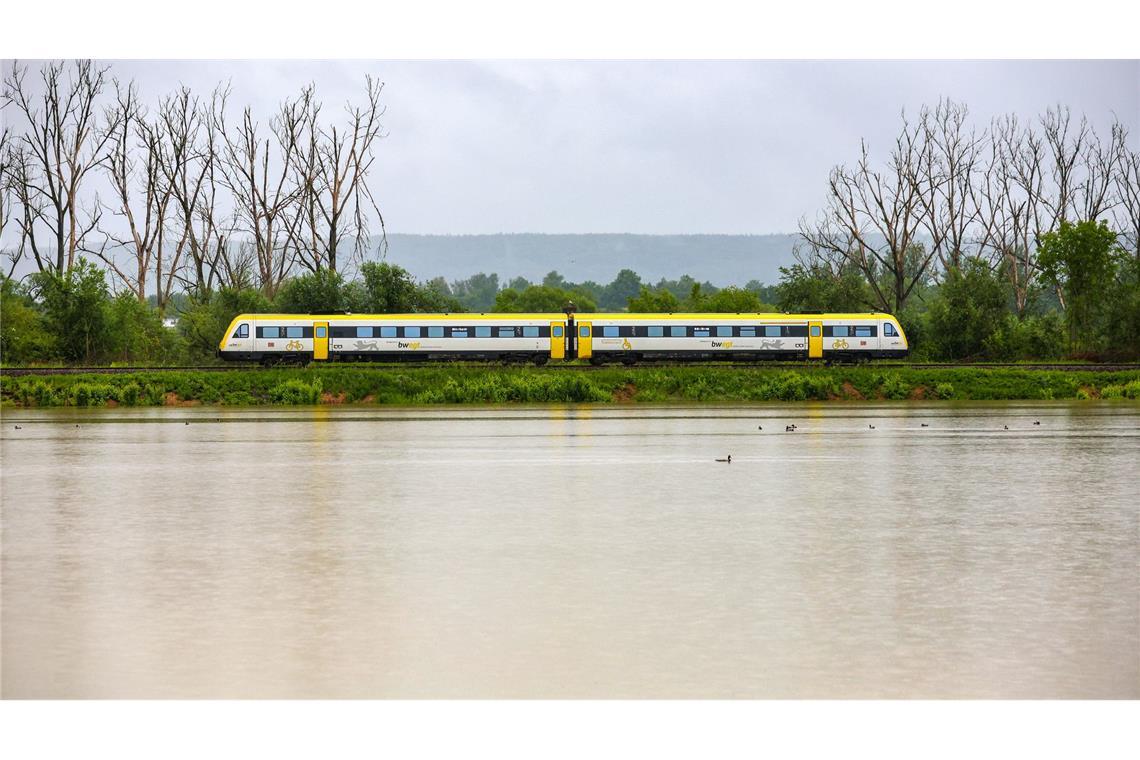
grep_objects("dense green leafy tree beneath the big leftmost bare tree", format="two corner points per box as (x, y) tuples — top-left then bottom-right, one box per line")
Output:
(32, 256), (112, 363)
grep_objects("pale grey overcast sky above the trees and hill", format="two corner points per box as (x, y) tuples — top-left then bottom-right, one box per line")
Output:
(5, 60), (1140, 234)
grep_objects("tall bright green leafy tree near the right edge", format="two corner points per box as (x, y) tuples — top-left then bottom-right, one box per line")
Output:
(1037, 220), (1126, 351)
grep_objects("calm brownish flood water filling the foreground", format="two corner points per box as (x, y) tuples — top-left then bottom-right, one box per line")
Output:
(0, 402), (1140, 698)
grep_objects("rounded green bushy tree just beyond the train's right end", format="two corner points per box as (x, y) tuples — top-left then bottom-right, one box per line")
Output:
(926, 259), (1010, 360)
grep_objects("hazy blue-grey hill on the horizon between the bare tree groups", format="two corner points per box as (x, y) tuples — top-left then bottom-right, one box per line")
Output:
(388, 234), (798, 287)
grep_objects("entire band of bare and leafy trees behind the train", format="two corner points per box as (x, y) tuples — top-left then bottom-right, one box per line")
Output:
(0, 62), (1140, 366)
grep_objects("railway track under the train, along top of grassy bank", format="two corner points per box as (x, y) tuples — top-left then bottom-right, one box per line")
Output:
(0, 361), (1140, 377)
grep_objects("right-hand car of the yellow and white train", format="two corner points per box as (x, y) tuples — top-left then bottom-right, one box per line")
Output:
(575, 313), (909, 363)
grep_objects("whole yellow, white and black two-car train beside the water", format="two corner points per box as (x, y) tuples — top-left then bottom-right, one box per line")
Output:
(218, 312), (907, 365)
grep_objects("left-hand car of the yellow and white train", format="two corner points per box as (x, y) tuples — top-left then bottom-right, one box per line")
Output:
(218, 313), (568, 365)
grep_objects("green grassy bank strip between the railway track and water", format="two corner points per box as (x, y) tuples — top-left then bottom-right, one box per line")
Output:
(0, 365), (1140, 407)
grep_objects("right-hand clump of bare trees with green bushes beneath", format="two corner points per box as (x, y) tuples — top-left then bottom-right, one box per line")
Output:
(792, 100), (1140, 358)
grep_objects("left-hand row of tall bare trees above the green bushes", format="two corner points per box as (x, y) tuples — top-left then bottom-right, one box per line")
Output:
(0, 60), (384, 300)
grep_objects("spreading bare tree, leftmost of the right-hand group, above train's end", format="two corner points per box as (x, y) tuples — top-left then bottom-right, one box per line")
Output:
(800, 115), (935, 312)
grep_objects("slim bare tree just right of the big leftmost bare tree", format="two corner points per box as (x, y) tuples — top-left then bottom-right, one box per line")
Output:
(88, 82), (170, 302)
